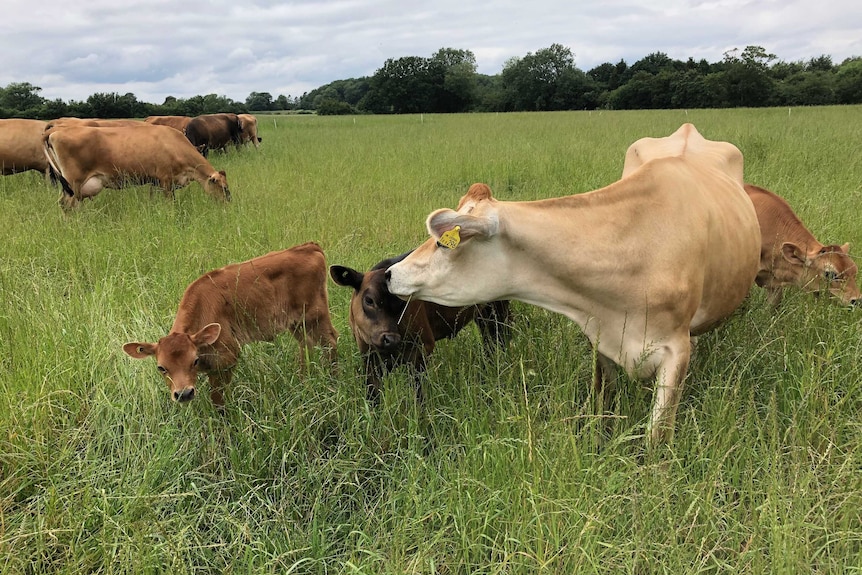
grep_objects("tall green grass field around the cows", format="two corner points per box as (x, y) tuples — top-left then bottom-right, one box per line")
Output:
(0, 107), (862, 575)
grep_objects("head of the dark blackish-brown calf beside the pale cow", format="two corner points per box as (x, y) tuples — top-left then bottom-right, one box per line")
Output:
(329, 260), (408, 353)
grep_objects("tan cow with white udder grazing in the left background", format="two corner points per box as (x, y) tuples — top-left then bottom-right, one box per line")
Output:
(44, 122), (230, 209)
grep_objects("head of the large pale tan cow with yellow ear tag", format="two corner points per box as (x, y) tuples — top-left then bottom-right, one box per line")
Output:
(386, 184), (510, 307)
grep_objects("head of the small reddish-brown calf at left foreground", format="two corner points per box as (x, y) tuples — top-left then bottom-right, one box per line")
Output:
(123, 323), (221, 402)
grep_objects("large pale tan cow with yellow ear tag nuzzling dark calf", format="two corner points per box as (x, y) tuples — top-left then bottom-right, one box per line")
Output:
(387, 124), (760, 442)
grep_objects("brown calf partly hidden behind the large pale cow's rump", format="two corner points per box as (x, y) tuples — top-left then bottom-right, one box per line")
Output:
(745, 184), (859, 306)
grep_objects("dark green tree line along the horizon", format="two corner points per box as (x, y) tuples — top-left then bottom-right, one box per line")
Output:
(0, 44), (862, 119)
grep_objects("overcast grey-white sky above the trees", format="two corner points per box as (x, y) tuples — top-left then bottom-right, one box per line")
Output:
(0, 0), (862, 104)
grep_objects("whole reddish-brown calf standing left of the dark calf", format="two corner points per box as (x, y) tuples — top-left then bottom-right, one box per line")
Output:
(123, 242), (338, 406)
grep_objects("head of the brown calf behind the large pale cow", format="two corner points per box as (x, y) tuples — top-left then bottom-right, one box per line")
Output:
(781, 242), (860, 305)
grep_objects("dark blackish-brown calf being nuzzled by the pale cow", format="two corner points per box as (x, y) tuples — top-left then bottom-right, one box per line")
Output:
(329, 254), (510, 401)
